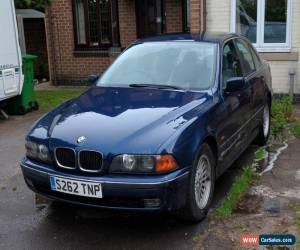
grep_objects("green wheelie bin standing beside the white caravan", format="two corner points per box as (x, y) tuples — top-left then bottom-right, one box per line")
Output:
(8, 54), (39, 115)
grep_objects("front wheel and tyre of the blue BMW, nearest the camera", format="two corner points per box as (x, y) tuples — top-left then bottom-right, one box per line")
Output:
(180, 143), (216, 222)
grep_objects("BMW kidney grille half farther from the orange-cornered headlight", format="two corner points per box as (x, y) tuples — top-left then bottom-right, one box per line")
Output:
(55, 148), (76, 169)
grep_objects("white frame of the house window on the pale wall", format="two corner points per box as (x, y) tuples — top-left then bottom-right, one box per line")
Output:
(230, 0), (292, 52)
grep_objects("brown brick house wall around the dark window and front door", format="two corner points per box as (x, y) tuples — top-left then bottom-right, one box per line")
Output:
(45, 0), (201, 85)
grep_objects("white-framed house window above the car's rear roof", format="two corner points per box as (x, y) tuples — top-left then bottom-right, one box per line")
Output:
(231, 0), (292, 52)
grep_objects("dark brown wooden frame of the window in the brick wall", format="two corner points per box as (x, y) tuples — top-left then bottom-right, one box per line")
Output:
(72, 0), (120, 51)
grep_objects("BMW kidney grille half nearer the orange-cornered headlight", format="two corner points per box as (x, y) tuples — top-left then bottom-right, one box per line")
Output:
(79, 150), (103, 172)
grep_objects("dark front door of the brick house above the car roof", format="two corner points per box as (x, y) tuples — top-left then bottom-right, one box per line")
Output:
(135, 0), (163, 38)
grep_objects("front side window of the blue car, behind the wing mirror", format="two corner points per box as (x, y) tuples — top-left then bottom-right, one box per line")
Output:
(222, 40), (243, 86)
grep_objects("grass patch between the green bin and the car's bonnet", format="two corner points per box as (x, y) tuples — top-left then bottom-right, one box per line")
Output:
(36, 88), (86, 111)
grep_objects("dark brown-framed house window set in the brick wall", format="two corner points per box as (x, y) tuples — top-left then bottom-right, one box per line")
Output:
(73, 0), (119, 50)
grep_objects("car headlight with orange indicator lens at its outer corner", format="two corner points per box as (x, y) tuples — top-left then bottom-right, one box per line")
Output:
(109, 154), (178, 173)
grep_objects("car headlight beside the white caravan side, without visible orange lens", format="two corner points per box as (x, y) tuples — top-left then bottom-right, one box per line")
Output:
(25, 141), (52, 163)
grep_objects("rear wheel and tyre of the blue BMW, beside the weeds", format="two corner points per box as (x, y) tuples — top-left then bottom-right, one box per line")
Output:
(254, 102), (271, 146)
